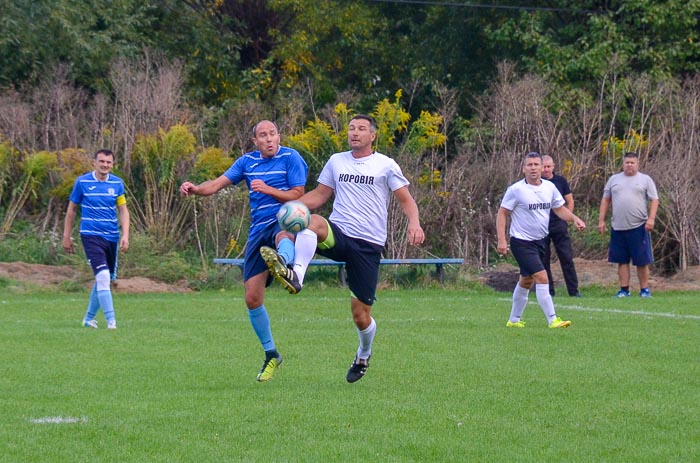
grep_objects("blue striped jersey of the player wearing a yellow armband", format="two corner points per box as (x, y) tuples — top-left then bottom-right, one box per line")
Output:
(70, 172), (126, 241)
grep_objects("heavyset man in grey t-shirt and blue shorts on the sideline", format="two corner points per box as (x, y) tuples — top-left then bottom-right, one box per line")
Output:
(598, 152), (659, 297)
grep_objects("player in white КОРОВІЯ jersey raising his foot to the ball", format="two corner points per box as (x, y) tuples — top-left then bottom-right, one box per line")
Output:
(261, 115), (425, 383)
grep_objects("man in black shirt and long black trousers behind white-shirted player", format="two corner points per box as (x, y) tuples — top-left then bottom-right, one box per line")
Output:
(542, 156), (581, 297)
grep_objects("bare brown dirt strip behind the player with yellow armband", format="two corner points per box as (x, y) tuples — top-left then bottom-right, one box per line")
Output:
(0, 262), (189, 293)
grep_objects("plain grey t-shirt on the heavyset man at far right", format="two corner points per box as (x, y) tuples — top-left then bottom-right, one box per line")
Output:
(603, 172), (659, 230)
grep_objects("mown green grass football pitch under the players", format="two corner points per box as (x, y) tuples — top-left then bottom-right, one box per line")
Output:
(0, 288), (700, 462)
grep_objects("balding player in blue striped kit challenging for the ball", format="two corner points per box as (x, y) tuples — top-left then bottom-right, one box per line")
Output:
(180, 120), (308, 381)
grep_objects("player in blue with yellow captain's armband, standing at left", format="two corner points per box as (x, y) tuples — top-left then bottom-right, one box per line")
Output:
(63, 149), (129, 330)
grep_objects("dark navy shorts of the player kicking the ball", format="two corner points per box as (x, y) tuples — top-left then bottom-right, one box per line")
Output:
(316, 221), (382, 305)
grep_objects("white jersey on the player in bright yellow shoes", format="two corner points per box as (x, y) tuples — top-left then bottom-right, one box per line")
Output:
(501, 179), (566, 241)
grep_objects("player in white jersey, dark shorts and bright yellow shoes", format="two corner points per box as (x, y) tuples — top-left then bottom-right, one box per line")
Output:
(496, 152), (586, 328)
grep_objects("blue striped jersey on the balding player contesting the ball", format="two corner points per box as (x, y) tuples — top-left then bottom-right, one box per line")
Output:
(224, 146), (309, 236)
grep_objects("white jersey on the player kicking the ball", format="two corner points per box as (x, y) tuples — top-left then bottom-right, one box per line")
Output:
(318, 151), (409, 246)
